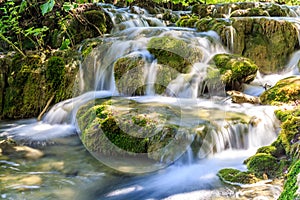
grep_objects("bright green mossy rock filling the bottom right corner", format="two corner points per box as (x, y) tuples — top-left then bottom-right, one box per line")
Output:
(278, 160), (300, 200)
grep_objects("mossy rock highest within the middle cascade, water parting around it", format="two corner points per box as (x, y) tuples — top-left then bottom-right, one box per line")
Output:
(147, 36), (203, 73)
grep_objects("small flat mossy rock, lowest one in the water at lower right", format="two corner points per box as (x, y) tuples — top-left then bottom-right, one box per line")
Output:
(217, 168), (261, 185)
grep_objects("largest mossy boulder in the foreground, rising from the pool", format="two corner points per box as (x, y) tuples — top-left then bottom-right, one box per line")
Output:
(77, 98), (188, 161)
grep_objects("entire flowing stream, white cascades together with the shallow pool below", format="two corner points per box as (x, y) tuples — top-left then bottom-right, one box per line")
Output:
(0, 4), (300, 200)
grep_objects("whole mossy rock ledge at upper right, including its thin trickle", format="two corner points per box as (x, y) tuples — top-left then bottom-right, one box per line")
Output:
(195, 18), (299, 74)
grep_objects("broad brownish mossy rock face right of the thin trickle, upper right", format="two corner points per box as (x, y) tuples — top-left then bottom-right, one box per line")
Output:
(232, 18), (298, 74)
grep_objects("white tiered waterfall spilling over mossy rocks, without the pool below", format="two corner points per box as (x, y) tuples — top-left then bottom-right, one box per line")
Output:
(1, 4), (300, 163)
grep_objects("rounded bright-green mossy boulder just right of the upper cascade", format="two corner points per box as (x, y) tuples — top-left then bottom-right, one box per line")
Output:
(209, 54), (258, 90)
